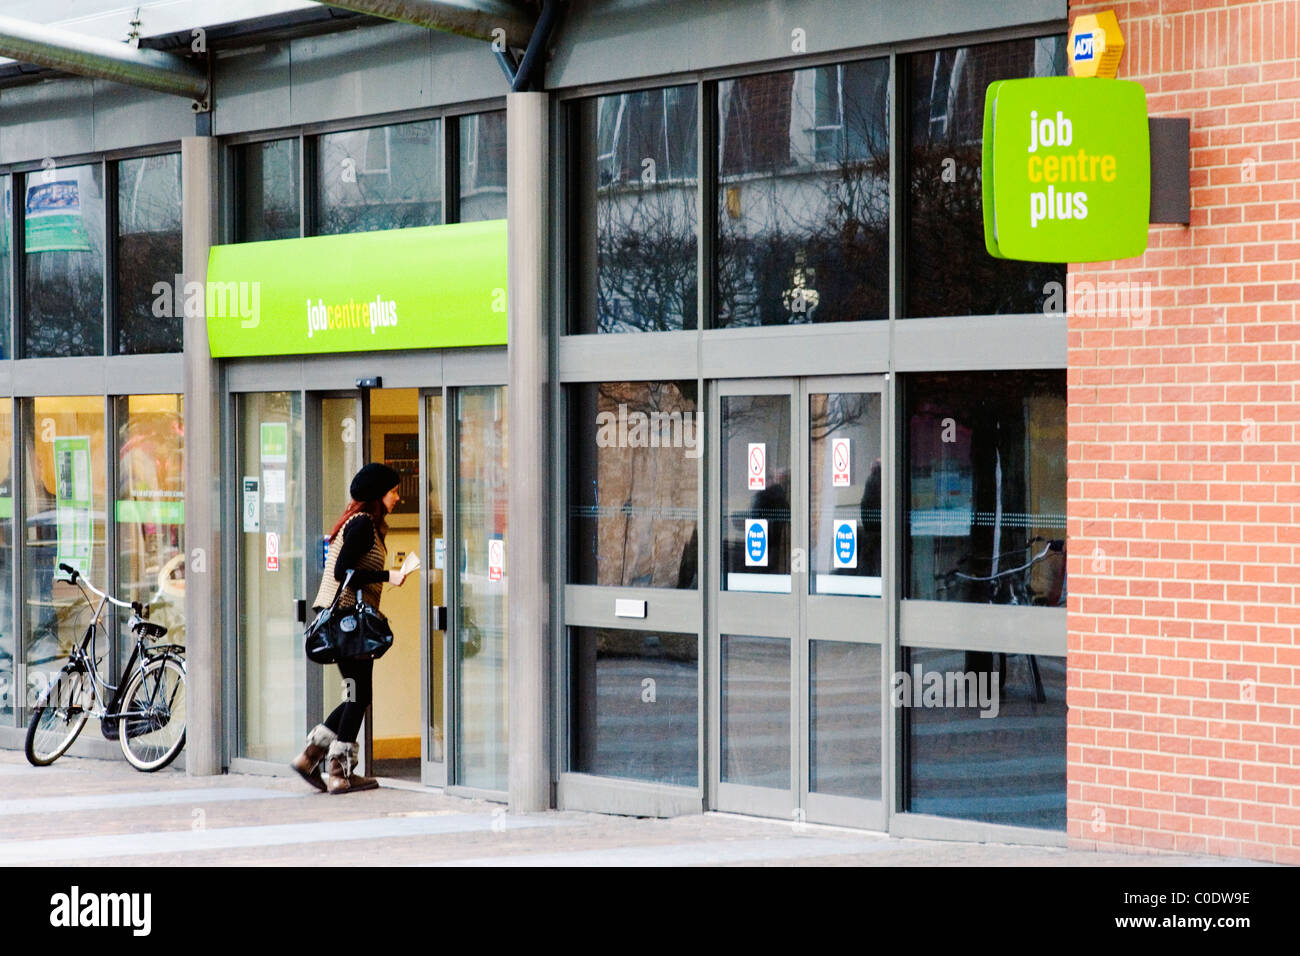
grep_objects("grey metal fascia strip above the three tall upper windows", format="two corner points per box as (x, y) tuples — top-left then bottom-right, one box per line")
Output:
(546, 0), (1066, 88)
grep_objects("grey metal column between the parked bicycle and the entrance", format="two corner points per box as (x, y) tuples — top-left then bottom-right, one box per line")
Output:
(181, 137), (222, 777)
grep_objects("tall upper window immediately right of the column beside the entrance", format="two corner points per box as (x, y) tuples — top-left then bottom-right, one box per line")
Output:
(571, 86), (699, 333)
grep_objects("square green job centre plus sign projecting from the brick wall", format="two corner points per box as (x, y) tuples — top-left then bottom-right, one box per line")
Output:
(983, 77), (1151, 263)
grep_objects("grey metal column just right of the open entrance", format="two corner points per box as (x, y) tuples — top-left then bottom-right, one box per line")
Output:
(506, 92), (554, 812)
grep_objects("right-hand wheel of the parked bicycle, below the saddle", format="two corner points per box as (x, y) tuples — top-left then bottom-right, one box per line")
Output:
(117, 657), (185, 773)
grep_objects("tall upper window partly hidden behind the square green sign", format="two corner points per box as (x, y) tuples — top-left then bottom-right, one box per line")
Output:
(905, 36), (1065, 316)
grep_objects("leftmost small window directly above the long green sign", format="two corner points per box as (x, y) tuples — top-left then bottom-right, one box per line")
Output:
(234, 138), (302, 242)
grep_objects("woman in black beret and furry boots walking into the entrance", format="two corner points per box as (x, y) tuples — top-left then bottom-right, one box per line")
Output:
(290, 462), (406, 793)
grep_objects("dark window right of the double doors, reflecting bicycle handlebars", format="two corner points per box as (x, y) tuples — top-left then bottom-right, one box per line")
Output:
(906, 371), (1066, 607)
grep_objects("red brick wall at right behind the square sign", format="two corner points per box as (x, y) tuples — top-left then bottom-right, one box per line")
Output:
(1069, 0), (1300, 864)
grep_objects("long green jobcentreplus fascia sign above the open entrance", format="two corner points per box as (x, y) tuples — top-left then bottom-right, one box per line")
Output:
(204, 220), (506, 358)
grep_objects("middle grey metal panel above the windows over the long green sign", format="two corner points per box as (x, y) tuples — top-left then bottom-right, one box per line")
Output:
(290, 23), (431, 124)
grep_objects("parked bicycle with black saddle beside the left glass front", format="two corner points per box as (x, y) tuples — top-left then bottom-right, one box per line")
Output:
(25, 564), (186, 773)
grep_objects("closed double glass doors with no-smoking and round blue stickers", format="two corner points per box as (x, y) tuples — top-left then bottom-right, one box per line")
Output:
(710, 377), (888, 827)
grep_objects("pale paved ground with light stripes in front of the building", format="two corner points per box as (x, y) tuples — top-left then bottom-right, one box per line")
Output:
(0, 750), (1263, 868)
